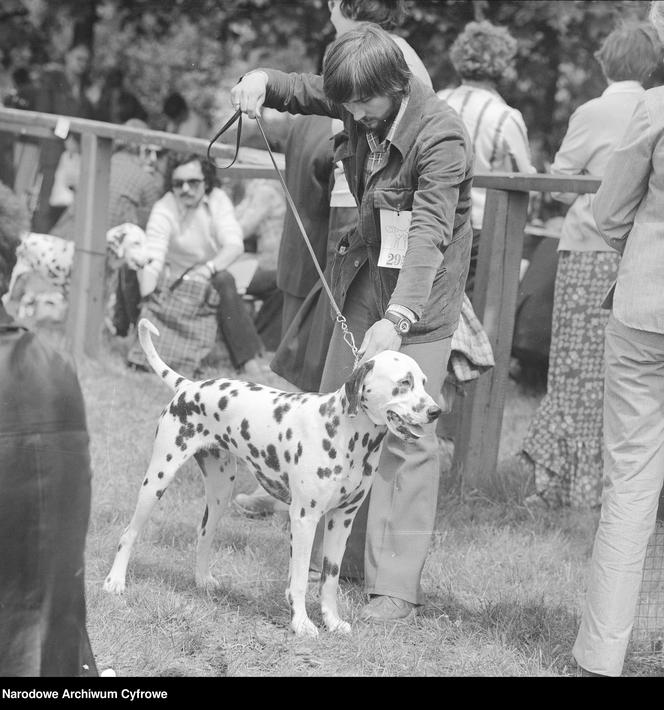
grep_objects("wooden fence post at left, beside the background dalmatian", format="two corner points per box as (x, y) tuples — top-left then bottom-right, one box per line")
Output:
(66, 133), (113, 357)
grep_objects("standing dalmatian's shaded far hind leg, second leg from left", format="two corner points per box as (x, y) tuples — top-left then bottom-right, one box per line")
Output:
(194, 449), (237, 589)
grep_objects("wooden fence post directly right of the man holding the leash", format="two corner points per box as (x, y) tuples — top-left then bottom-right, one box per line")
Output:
(452, 190), (528, 490)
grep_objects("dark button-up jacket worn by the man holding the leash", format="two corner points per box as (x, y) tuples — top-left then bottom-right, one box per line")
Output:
(262, 69), (473, 343)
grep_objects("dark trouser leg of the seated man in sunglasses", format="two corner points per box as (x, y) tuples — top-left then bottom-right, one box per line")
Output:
(212, 271), (263, 368)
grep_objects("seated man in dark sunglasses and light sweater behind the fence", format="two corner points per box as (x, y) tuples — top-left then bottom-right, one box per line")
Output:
(138, 155), (263, 375)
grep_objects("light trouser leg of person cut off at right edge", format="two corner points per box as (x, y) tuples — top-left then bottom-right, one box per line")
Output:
(572, 316), (664, 676)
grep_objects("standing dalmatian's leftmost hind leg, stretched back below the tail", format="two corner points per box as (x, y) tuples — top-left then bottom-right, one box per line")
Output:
(104, 440), (193, 594)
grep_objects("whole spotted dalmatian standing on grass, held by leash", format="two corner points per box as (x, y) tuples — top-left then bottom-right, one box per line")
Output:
(104, 319), (441, 636)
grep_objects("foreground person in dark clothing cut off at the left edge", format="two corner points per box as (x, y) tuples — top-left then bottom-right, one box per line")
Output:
(0, 179), (97, 677)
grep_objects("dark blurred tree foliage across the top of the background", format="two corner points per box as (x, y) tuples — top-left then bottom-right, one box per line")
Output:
(4, 0), (649, 160)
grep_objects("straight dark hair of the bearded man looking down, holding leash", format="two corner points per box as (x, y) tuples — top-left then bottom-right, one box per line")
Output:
(323, 23), (411, 103)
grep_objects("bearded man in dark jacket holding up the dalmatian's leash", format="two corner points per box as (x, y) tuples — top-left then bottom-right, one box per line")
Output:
(231, 24), (472, 621)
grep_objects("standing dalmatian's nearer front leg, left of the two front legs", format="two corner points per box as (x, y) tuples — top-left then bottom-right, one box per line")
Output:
(286, 501), (320, 636)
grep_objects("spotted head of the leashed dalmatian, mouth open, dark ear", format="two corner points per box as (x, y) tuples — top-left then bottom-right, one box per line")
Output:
(345, 350), (441, 440)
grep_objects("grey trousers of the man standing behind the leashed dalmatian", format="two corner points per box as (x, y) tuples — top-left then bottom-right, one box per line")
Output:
(311, 265), (451, 604)
